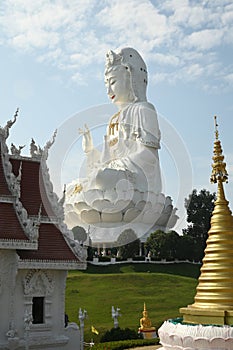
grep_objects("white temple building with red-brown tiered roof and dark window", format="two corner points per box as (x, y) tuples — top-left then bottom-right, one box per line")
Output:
(0, 113), (86, 350)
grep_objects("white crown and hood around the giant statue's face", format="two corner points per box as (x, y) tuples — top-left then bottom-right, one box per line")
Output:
(105, 47), (147, 106)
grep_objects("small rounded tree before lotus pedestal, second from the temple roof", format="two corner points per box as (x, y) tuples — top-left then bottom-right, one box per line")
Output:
(117, 229), (140, 260)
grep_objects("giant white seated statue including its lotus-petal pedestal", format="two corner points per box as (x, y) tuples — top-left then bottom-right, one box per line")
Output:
(65, 48), (178, 245)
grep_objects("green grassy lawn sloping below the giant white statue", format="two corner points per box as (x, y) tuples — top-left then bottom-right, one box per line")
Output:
(66, 264), (199, 341)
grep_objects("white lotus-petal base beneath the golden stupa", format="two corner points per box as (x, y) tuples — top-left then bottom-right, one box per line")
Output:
(158, 319), (233, 350)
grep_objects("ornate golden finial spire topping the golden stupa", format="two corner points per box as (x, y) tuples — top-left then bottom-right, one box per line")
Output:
(210, 116), (228, 183)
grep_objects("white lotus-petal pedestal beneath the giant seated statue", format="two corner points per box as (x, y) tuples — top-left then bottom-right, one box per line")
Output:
(65, 189), (178, 248)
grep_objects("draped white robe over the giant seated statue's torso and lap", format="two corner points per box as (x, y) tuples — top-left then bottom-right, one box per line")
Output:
(92, 102), (161, 194)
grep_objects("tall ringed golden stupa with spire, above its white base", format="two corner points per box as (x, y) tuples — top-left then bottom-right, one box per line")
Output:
(180, 117), (233, 325)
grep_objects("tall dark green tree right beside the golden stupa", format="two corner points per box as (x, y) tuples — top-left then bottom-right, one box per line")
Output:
(183, 189), (216, 260)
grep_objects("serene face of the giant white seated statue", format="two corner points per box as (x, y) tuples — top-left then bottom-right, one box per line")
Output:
(105, 66), (134, 107)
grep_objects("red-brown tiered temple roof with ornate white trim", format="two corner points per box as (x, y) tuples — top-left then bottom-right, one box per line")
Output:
(0, 129), (86, 269)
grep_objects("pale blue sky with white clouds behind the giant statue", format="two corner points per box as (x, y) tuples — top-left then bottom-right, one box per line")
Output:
(0, 0), (233, 232)
